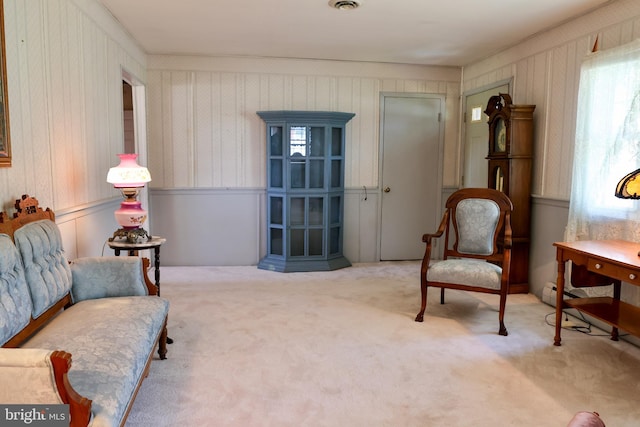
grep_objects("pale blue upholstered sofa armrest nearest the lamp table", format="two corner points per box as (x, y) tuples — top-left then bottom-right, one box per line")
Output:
(71, 256), (148, 303)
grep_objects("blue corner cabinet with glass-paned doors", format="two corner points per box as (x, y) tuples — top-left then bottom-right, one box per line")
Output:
(257, 111), (355, 272)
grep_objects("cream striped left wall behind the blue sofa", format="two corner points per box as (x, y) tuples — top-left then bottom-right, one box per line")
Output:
(0, 0), (146, 256)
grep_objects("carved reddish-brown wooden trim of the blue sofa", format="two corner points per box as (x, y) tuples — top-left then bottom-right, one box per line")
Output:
(0, 195), (167, 427)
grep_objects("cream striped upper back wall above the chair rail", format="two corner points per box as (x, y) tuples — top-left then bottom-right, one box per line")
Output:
(147, 56), (460, 188)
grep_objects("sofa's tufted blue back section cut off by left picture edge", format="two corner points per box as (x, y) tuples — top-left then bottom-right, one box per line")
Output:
(0, 234), (33, 345)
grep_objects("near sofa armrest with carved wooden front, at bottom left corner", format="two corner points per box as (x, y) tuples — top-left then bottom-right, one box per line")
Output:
(0, 348), (91, 427)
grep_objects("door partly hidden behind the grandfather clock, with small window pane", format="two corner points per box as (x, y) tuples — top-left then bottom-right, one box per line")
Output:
(462, 84), (509, 188)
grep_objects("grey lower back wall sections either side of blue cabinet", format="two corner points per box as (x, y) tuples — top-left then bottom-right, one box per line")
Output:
(150, 188), (379, 266)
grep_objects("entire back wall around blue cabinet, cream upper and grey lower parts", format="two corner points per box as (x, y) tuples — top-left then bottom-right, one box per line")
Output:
(147, 56), (460, 265)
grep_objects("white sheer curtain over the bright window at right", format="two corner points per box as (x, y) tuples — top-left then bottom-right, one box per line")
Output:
(565, 40), (640, 246)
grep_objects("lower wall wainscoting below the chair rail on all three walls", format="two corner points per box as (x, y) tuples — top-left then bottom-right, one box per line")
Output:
(56, 188), (569, 297)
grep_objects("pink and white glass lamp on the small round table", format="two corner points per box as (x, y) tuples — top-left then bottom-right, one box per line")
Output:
(107, 154), (151, 243)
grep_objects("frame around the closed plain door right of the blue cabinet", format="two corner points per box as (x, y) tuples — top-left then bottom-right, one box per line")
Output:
(376, 92), (447, 261)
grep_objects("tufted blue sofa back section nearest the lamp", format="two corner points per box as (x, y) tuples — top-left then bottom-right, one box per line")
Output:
(14, 219), (71, 319)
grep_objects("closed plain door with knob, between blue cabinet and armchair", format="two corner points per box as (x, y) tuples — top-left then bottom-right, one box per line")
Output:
(380, 94), (444, 260)
